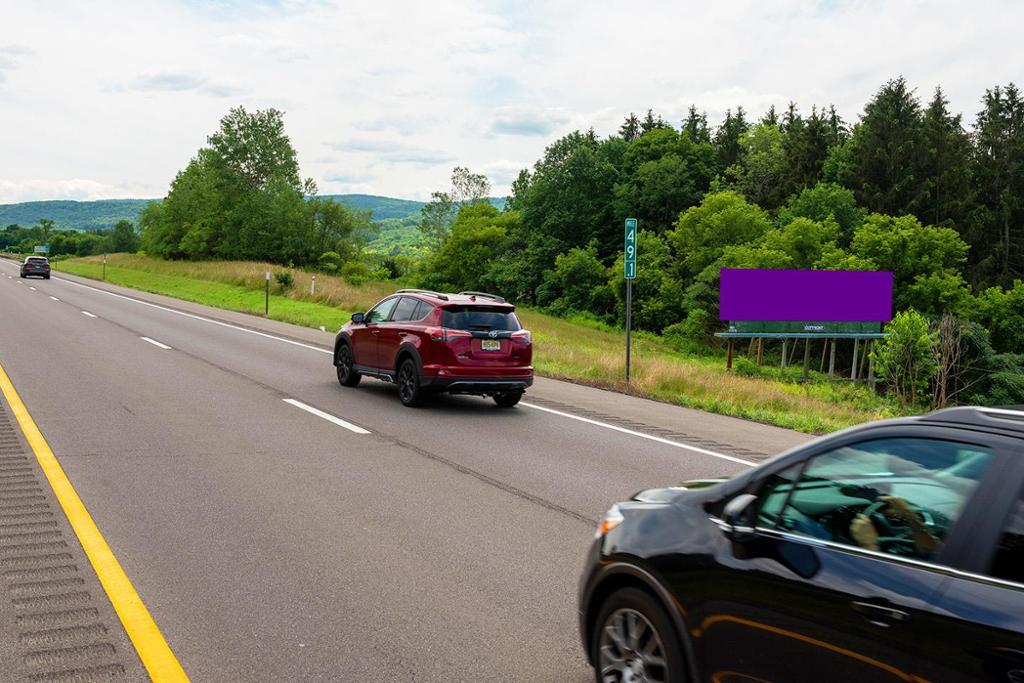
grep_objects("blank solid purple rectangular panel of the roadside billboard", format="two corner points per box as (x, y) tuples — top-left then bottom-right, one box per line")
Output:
(719, 268), (893, 323)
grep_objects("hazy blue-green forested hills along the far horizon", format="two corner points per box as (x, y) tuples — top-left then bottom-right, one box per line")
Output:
(0, 195), (505, 230)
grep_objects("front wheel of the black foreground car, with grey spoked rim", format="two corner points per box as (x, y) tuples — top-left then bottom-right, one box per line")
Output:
(591, 588), (686, 683)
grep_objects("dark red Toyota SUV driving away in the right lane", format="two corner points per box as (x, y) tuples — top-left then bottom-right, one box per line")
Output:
(334, 290), (534, 408)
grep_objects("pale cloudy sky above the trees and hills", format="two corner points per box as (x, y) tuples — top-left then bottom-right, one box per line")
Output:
(0, 0), (1024, 203)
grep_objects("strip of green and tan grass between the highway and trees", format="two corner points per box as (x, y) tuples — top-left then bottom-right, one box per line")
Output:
(53, 254), (894, 433)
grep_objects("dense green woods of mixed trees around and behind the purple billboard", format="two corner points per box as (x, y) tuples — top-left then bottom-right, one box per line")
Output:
(420, 78), (1024, 400)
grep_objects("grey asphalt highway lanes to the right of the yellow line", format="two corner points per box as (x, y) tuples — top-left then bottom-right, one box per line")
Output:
(0, 261), (806, 682)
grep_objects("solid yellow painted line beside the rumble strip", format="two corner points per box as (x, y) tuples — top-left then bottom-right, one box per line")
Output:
(0, 366), (188, 683)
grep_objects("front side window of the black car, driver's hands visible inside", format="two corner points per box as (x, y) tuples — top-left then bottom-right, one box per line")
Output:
(776, 438), (992, 559)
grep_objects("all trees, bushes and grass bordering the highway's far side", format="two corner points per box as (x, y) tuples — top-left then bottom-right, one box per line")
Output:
(16, 78), (1024, 431)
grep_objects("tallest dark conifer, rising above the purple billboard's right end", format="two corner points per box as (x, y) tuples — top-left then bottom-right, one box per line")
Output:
(841, 77), (928, 215)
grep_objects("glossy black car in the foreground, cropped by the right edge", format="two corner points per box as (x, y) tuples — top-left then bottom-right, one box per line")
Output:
(580, 408), (1024, 683)
